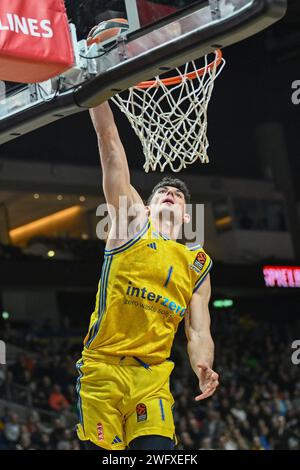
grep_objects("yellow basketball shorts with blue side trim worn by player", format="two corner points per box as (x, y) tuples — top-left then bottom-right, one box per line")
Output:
(76, 358), (176, 450)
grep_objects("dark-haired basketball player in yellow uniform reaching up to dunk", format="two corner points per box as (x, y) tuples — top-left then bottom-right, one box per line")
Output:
(77, 103), (219, 450)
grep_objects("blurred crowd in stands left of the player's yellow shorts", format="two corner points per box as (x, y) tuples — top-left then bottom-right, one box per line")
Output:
(0, 326), (82, 450)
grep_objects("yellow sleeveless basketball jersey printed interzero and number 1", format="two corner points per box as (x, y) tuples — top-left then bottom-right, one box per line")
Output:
(83, 220), (212, 364)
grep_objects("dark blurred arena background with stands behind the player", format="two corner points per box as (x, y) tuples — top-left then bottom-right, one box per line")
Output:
(0, 0), (300, 450)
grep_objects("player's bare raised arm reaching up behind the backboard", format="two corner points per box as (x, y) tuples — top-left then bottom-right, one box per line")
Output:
(90, 102), (143, 217)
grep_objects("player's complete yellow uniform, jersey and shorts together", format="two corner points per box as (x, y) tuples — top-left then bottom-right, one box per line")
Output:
(77, 220), (212, 449)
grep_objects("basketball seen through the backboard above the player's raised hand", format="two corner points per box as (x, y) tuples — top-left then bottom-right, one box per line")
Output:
(87, 18), (129, 46)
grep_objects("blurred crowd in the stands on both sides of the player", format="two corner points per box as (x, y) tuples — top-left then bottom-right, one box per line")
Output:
(0, 311), (300, 450)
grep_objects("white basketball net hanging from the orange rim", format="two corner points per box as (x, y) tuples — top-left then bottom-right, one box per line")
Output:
(112, 53), (225, 172)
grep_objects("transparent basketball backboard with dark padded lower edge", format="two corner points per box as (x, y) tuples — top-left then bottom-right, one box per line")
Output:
(0, 0), (287, 143)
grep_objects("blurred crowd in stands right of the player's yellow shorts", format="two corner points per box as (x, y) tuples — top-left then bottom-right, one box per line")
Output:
(173, 314), (300, 450)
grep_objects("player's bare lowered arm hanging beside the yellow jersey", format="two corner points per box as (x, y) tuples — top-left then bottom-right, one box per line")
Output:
(185, 275), (219, 401)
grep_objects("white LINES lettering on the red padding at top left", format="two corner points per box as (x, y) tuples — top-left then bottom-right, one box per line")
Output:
(0, 13), (54, 38)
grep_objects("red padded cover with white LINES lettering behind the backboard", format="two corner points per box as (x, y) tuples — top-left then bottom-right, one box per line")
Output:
(0, 0), (74, 83)
